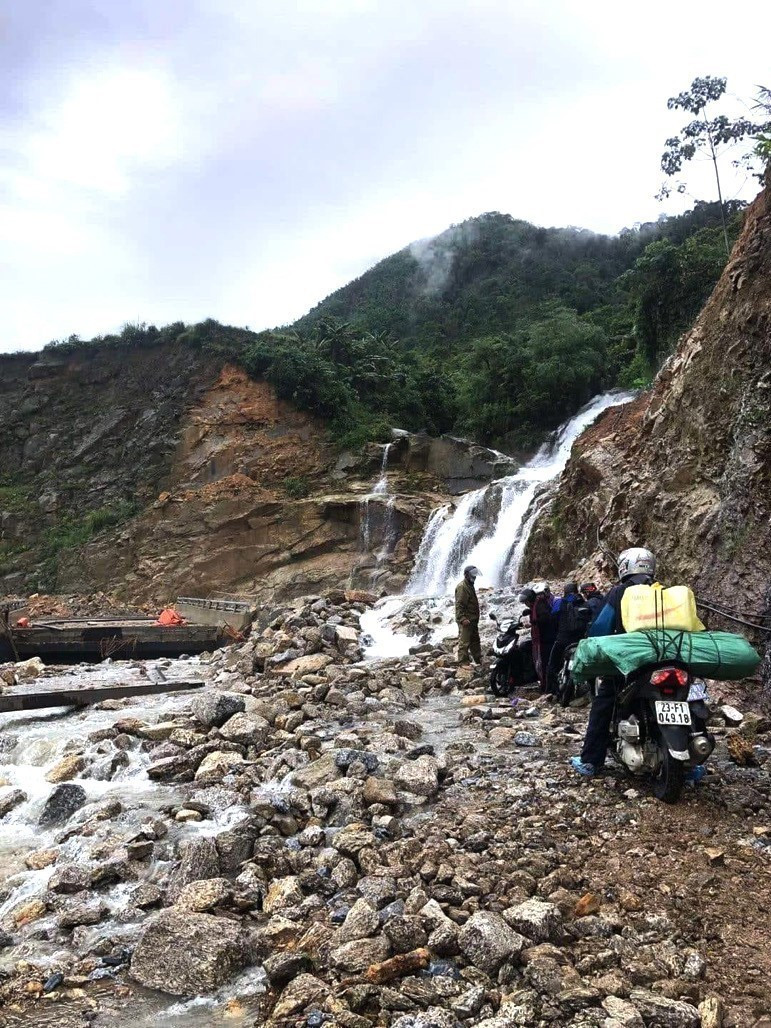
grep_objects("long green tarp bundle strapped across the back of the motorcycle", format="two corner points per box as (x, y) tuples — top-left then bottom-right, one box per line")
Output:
(573, 630), (761, 682)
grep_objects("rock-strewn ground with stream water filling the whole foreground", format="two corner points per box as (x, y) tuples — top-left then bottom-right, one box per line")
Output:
(0, 593), (771, 1028)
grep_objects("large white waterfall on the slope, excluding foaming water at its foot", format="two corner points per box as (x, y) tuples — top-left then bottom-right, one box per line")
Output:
(407, 391), (634, 596)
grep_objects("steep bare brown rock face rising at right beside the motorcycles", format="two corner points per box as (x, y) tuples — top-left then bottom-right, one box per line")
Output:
(523, 173), (771, 690)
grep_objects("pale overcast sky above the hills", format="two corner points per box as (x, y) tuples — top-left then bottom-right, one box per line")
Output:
(0, 0), (771, 351)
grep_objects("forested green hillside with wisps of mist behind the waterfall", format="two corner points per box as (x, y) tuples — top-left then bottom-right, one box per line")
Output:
(39, 195), (742, 448)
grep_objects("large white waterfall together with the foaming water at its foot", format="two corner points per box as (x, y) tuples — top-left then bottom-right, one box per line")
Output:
(362, 391), (634, 657)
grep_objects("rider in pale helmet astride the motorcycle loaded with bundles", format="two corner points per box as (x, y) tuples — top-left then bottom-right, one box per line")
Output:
(571, 546), (656, 777)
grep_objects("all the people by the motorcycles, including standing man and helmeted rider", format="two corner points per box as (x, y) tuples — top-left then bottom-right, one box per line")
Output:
(455, 547), (686, 776)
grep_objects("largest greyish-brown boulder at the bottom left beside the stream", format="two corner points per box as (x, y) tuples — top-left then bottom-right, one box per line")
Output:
(131, 910), (247, 996)
